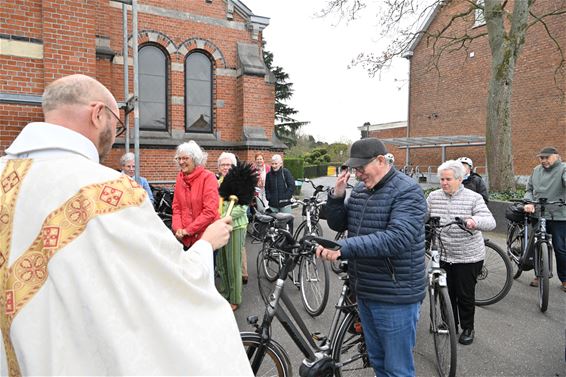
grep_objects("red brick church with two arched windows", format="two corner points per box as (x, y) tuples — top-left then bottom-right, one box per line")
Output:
(0, 0), (285, 180)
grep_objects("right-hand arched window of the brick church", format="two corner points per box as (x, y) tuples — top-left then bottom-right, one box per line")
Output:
(185, 52), (212, 132)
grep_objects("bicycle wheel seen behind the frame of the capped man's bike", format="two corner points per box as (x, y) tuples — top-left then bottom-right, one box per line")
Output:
(299, 254), (330, 317)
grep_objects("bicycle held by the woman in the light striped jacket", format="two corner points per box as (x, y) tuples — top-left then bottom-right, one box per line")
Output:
(426, 216), (462, 377)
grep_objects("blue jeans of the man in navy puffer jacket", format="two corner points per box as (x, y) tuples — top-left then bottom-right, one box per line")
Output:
(358, 297), (420, 377)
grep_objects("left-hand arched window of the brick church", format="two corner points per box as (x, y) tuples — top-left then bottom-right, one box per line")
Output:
(138, 44), (168, 131)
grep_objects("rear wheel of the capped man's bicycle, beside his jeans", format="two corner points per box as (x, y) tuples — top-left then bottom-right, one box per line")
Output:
(332, 312), (374, 377)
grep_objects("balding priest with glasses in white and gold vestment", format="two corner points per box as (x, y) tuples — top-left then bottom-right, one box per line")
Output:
(0, 75), (252, 376)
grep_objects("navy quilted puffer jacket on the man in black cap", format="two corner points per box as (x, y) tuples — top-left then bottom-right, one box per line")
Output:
(327, 169), (427, 304)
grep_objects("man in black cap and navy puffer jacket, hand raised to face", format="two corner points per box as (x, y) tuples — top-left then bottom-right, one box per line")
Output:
(317, 138), (427, 376)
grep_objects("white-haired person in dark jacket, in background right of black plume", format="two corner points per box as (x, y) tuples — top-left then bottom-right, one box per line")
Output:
(265, 154), (295, 213)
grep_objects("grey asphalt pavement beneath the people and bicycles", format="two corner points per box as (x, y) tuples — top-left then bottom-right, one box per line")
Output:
(236, 177), (566, 377)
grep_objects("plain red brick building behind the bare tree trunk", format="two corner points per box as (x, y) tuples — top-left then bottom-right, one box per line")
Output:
(375, 0), (566, 176)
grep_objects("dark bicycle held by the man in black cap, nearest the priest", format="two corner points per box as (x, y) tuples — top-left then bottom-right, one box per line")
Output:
(244, 229), (374, 377)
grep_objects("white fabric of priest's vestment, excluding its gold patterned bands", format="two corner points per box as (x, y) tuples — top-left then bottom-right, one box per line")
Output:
(0, 123), (252, 375)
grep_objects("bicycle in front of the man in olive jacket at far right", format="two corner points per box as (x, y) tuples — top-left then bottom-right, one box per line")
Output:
(506, 198), (566, 313)
